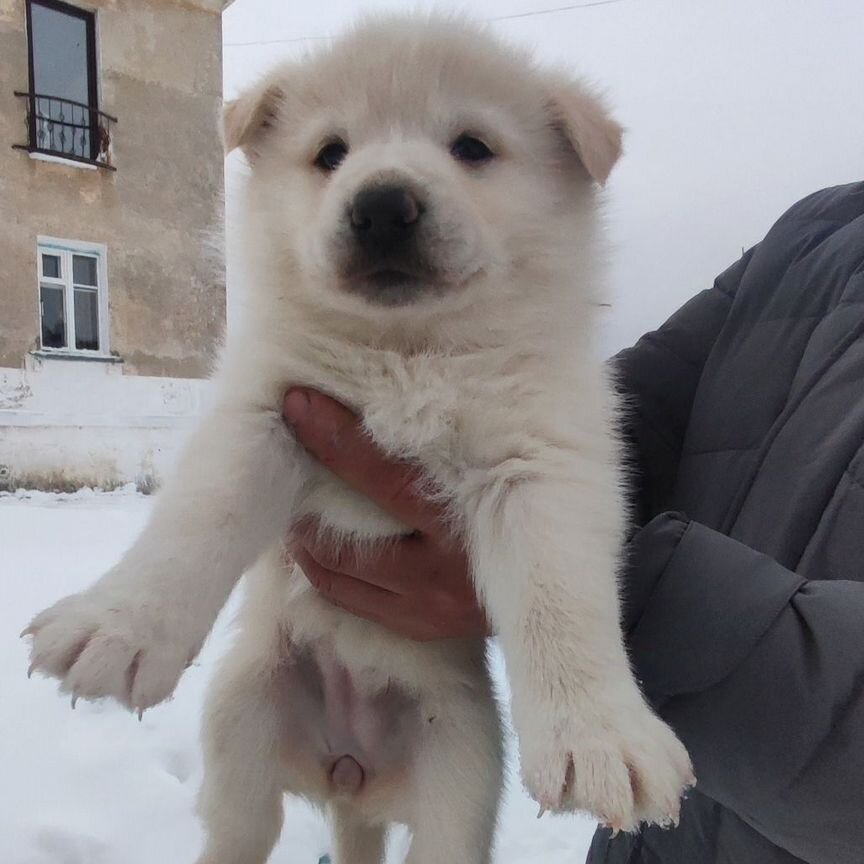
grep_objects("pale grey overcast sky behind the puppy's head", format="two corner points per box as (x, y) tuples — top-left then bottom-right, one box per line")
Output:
(224, 0), (864, 351)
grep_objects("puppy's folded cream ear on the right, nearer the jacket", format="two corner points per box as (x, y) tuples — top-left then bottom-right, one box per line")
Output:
(548, 76), (624, 185)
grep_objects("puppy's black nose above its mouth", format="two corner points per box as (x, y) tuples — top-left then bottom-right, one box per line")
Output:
(351, 185), (422, 255)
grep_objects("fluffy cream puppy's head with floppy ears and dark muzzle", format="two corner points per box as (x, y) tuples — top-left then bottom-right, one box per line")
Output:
(224, 17), (621, 316)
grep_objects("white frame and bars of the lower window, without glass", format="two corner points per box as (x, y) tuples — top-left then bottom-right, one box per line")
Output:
(36, 235), (111, 357)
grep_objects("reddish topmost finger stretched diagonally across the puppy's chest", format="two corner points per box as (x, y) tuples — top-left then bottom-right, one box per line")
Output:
(283, 389), (444, 533)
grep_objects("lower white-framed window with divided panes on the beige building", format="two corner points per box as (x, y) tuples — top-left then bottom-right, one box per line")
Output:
(38, 238), (108, 354)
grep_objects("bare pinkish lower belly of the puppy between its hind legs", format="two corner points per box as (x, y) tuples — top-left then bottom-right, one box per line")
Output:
(277, 642), (422, 799)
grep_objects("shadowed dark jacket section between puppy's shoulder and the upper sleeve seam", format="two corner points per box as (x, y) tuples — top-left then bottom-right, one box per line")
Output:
(611, 250), (753, 525)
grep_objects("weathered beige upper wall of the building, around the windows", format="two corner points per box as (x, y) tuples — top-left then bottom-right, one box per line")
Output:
(0, 0), (225, 378)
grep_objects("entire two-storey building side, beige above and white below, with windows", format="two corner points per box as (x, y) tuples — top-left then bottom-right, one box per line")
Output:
(0, 0), (227, 487)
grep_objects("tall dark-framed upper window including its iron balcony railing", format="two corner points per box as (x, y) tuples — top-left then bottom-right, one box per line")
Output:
(16, 0), (115, 166)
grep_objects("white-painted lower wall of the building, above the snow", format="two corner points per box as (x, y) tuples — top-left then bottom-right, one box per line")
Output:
(0, 357), (210, 491)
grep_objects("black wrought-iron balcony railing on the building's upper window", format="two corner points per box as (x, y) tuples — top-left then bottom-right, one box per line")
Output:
(15, 90), (117, 171)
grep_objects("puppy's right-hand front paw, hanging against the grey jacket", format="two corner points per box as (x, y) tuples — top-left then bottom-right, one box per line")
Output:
(522, 699), (695, 831)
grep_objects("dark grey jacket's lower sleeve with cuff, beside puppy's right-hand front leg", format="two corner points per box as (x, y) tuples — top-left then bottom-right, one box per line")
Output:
(625, 513), (864, 864)
